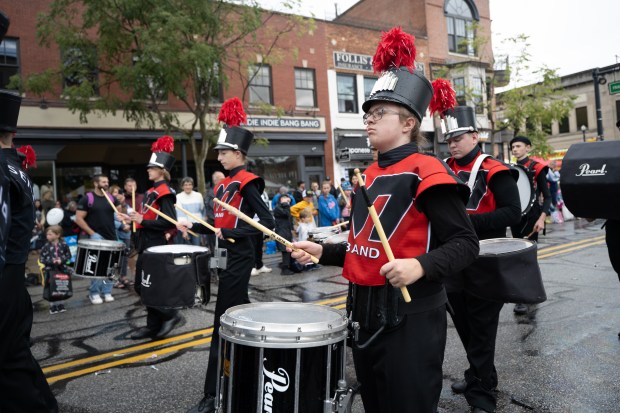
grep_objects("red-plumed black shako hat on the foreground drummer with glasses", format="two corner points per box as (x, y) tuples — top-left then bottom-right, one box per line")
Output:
(362, 27), (433, 121)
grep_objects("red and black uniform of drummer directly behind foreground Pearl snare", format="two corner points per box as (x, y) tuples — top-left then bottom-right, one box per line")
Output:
(192, 166), (274, 396)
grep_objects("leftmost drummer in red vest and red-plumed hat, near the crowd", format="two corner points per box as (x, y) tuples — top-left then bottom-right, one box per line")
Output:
(125, 136), (180, 340)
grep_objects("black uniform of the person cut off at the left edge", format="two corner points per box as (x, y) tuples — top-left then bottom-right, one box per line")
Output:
(0, 148), (58, 413)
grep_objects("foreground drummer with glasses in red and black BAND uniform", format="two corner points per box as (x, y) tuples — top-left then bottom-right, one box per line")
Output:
(292, 28), (479, 413)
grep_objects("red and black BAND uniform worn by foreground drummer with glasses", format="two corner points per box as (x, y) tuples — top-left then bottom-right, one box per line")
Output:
(321, 143), (478, 413)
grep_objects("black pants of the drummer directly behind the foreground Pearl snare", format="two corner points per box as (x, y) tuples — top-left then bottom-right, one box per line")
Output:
(204, 238), (252, 396)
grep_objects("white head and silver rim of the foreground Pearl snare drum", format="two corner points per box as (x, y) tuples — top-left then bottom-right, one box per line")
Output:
(220, 302), (347, 348)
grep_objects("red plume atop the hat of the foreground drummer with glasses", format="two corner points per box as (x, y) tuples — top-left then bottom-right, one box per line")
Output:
(372, 26), (416, 73)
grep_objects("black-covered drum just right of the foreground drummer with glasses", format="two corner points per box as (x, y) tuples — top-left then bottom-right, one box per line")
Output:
(464, 238), (547, 304)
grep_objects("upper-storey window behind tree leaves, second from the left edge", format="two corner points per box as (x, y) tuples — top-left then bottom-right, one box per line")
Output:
(62, 47), (99, 95)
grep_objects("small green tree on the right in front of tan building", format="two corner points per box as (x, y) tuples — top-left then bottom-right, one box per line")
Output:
(498, 35), (574, 157)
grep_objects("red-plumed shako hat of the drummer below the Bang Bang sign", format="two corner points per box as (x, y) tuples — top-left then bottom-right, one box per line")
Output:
(213, 97), (254, 155)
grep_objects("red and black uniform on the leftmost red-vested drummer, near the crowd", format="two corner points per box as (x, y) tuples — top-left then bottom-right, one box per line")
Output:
(134, 180), (178, 333)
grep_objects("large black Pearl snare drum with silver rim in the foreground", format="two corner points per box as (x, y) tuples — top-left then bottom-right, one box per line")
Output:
(216, 303), (347, 413)
